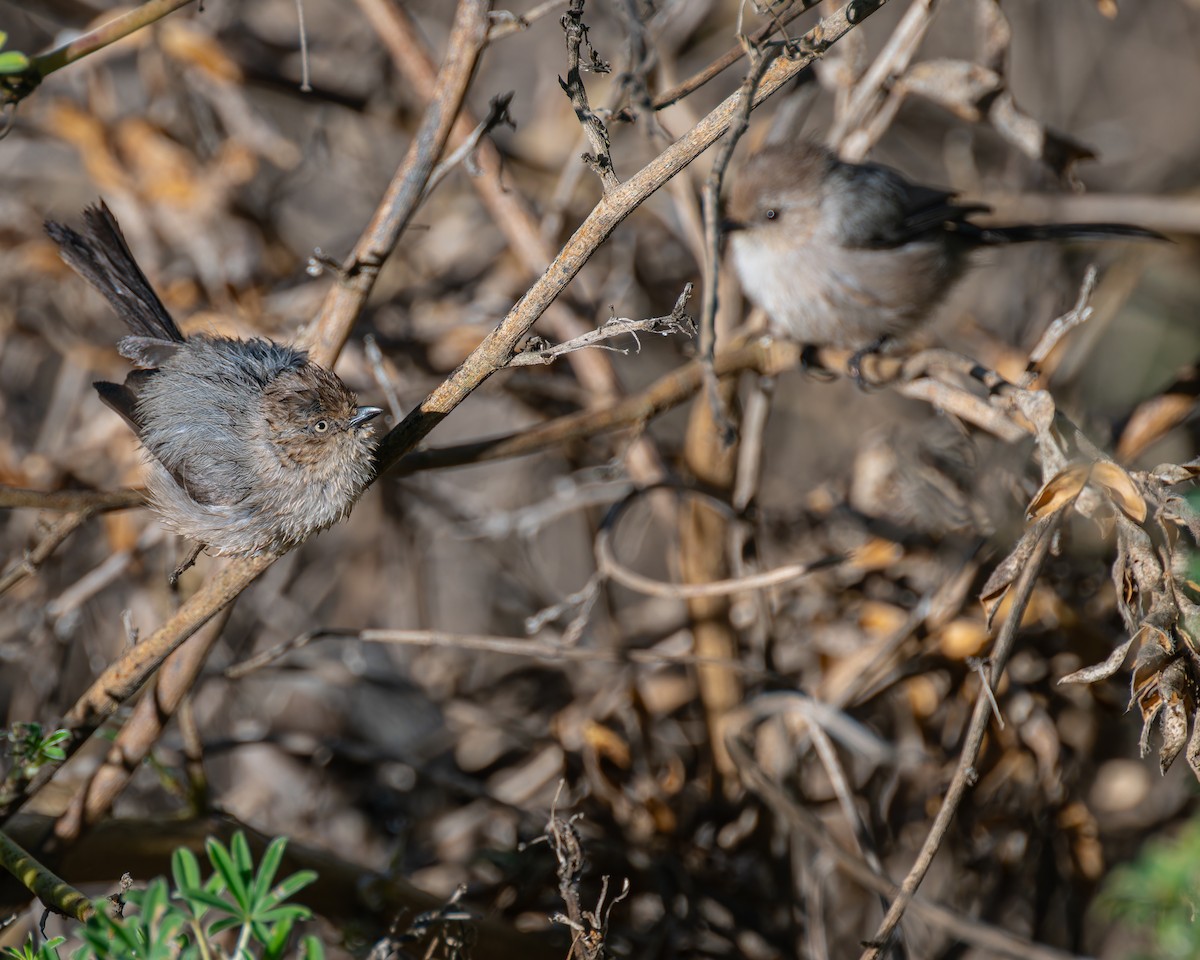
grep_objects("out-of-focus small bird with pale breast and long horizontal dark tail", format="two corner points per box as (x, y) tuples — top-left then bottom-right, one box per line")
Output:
(724, 143), (1166, 352)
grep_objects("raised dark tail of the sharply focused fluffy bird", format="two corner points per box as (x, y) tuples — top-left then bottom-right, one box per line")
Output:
(46, 202), (185, 343)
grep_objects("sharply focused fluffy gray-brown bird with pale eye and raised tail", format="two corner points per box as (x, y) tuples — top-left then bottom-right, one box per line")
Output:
(46, 203), (382, 581)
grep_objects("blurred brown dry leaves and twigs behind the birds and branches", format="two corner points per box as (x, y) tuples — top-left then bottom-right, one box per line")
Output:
(0, 0), (1200, 959)
